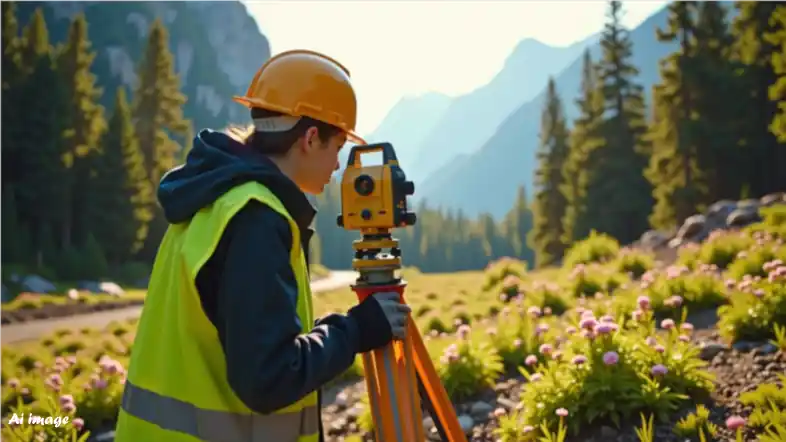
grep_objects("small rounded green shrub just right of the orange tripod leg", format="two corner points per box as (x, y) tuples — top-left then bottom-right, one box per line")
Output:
(437, 325), (503, 400)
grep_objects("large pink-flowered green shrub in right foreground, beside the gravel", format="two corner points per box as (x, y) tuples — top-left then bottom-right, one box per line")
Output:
(521, 300), (712, 434)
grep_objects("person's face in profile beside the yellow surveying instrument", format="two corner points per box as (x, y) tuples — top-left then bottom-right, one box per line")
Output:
(298, 127), (347, 195)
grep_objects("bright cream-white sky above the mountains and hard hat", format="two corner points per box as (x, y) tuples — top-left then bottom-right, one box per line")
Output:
(243, 0), (668, 135)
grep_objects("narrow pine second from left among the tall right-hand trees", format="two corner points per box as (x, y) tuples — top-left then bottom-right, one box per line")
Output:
(562, 49), (603, 245)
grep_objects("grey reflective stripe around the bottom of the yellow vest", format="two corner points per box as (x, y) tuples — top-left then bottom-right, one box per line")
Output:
(122, 381), (319, 442)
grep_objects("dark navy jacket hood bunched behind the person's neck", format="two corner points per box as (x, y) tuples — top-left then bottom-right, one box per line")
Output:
(158, 129), (316, 228)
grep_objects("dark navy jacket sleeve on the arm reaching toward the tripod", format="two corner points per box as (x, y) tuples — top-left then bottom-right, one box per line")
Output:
(215, 202), (359, 413)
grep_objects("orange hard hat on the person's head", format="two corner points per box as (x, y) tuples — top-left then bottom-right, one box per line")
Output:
(233, 49), (366, 144)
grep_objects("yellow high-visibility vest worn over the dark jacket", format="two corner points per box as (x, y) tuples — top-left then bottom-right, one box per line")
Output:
(115, 182), (319, 442)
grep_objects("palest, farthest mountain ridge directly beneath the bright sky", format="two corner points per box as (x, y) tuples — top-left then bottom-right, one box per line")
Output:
(407, 36), (598, 184)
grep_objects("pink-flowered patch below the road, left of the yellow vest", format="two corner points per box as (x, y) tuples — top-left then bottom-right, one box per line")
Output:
(2, 324), (133, 441)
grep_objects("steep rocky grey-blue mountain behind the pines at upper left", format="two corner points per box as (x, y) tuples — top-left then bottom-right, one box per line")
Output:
(17, 1), (270, 130)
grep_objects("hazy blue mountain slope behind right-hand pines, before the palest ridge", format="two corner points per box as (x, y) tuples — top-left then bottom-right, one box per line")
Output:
(416, 7), (676, 219)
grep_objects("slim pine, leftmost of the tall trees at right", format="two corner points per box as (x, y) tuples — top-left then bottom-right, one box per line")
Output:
(528, 78), (569, 267)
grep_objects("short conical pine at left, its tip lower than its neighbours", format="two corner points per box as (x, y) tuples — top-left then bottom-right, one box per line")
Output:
(92, 87), (153, 265)
